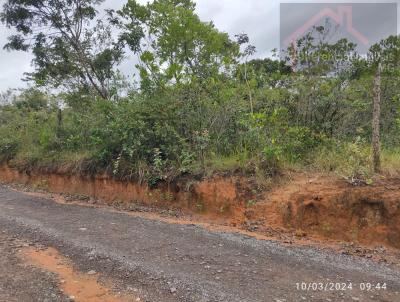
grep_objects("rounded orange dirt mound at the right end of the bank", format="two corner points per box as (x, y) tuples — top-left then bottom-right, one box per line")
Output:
(248, 175), (400, 248)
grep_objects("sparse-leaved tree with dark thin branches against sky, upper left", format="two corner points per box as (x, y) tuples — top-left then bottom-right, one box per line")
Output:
(0, 0), (123, 99)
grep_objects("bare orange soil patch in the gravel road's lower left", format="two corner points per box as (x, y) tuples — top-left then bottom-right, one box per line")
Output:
(22, 248), (134, 302)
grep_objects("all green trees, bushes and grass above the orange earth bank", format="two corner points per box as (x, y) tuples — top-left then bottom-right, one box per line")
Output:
(0, 0), (400, 185)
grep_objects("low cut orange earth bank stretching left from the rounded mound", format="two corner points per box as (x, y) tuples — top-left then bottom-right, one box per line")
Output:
(0, 165), (251, 219)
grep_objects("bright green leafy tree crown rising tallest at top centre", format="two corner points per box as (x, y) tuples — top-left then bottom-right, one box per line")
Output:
(119, 0), (239, 90)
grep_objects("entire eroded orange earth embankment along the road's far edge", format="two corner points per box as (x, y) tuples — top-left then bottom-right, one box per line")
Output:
(0, 165), (400, 248)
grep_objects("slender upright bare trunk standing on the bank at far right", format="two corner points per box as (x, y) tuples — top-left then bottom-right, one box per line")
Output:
(372, 63), (382, 173)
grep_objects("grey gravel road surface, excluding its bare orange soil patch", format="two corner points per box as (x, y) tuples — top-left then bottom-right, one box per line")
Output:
(0, 186), (400, 302)
